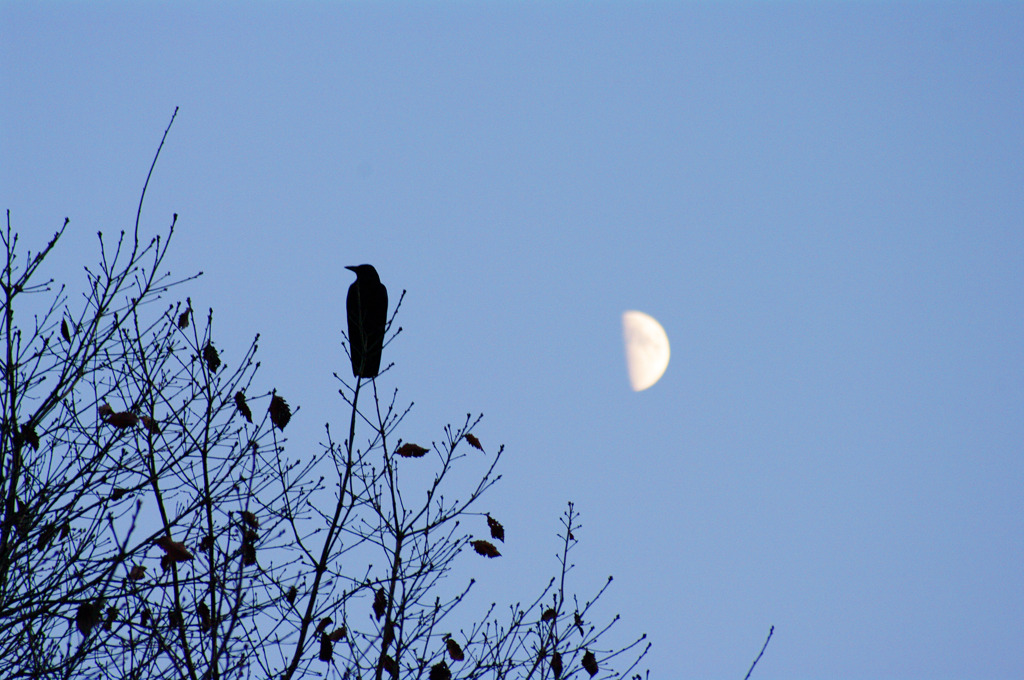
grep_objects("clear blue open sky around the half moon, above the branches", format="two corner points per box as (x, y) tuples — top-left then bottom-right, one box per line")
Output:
(0, 1), (1024, 679)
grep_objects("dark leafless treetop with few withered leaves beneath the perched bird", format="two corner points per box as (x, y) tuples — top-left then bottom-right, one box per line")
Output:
(0, 119), (649, 680)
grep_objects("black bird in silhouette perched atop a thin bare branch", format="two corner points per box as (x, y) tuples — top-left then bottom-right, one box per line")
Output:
(345, 264), (387, 378)
